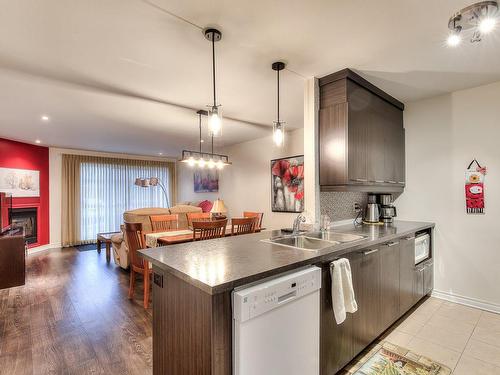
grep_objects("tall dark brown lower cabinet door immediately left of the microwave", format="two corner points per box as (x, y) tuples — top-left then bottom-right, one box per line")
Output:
(399, 235), (415, 315)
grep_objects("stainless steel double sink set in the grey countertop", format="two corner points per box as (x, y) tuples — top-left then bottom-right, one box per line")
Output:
(263, 231), (367, 251)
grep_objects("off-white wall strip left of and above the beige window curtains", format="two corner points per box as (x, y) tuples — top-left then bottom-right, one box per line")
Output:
(47, 147), (172, 248)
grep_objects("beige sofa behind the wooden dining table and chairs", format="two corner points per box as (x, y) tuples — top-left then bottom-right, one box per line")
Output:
(111, 204), (202, 269)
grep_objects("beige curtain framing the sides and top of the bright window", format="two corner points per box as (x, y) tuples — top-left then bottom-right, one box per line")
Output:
(61, 154), (177, 246)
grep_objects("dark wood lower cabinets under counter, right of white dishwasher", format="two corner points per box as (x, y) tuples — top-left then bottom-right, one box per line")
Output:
(320, 234), (433, 375)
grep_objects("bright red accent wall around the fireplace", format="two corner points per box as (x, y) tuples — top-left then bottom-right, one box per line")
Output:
(0, 138), (50, 245)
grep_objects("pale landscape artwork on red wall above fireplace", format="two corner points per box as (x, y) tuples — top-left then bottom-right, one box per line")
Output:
(0, 168), (40, 197)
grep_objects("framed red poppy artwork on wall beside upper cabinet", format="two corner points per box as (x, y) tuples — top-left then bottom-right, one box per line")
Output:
(271, 155), (304, 212)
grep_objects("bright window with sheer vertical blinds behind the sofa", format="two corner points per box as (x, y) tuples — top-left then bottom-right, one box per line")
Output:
(80, 159), (172, 242)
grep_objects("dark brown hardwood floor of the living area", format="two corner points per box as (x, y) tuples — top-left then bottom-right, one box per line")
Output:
(0, 248), (152, 375)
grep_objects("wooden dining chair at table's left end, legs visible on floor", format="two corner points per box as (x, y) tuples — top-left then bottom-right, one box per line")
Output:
(125, 223), (153, 309)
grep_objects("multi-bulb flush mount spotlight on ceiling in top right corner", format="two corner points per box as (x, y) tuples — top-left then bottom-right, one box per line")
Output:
(446, 0), (498, 47)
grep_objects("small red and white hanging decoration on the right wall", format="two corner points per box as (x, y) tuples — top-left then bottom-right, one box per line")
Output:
(465, 159), (486, 214)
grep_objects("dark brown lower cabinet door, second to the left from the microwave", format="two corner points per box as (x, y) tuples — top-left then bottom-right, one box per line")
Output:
(380, 240), (401, 332)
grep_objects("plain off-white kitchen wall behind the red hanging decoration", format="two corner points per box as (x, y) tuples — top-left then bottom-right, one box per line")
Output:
(396, 82), (500, 311)
